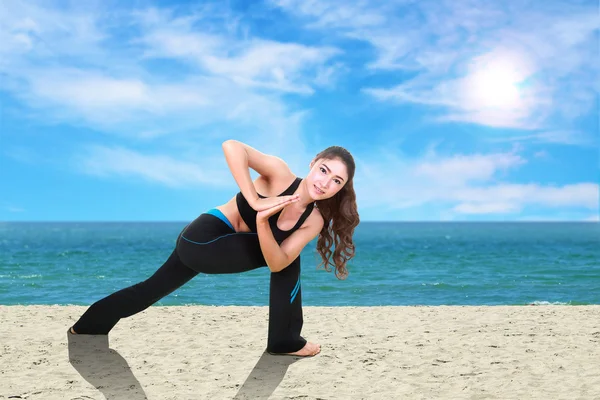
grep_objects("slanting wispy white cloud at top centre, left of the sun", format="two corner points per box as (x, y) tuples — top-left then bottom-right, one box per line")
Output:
(136, 6), (340, 94)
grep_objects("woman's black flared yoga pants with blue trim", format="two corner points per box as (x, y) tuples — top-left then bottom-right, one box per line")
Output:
(73, 210), (306, 353)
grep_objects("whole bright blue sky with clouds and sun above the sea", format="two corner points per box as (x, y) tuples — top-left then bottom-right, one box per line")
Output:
(0, 0), (600, 221)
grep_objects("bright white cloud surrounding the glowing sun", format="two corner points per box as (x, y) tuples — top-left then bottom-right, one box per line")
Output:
(273, 0), (600, 134)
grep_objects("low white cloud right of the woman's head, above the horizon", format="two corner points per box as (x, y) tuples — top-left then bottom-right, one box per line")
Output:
(355, 148), (600, 219)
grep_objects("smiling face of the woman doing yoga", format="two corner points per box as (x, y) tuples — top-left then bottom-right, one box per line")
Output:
(306, 159), (348, 200)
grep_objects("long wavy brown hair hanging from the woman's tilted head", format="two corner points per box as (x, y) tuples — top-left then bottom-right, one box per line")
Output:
(314, 146), (360, 280)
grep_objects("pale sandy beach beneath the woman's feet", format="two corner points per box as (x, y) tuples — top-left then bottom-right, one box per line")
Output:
(0, 305), (600, 400)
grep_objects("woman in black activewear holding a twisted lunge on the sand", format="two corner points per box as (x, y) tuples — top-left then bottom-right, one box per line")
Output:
(68, 140), (359, 356)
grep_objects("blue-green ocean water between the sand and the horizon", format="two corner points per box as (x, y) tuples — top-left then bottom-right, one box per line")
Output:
(0, 222), (600, 306)
